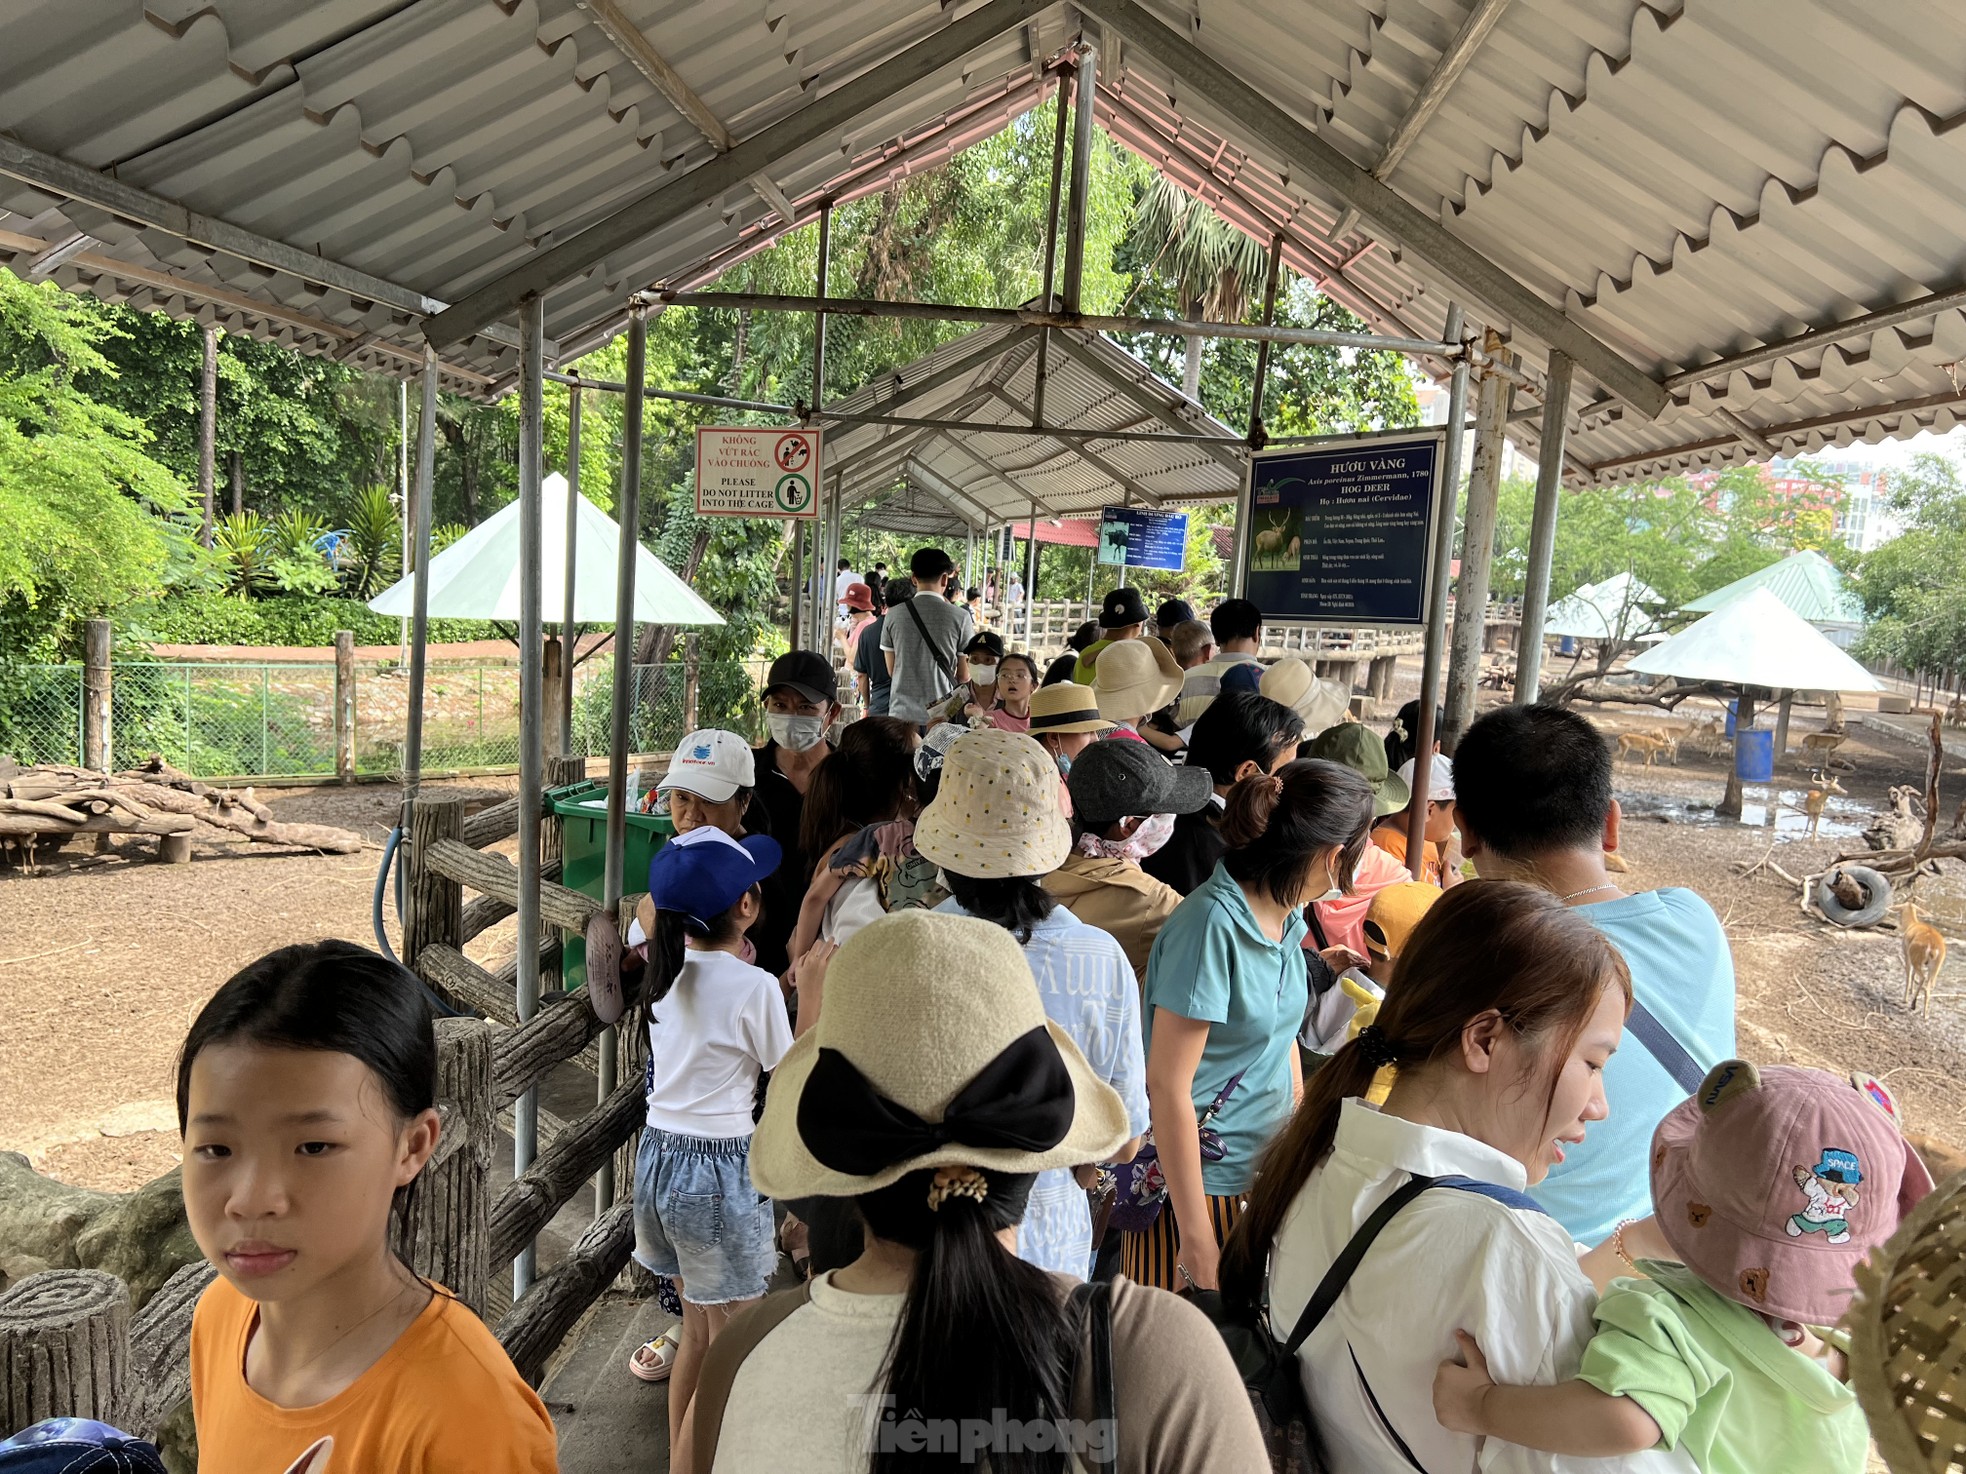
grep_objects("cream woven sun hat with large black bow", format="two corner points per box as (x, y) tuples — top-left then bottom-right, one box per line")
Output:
(751, 911), (1132, 1199)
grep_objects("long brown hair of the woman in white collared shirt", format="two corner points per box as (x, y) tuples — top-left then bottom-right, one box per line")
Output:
(1221, 876), (1632, 1305)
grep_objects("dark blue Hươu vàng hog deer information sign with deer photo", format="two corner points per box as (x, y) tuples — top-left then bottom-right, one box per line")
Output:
(1237, 430), (1445, 625)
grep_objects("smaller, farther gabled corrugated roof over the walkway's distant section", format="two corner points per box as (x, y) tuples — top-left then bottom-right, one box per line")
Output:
(820, 326), (1246, 527)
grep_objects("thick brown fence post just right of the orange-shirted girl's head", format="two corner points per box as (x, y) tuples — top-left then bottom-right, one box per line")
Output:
(401, 1021), (503, 1315)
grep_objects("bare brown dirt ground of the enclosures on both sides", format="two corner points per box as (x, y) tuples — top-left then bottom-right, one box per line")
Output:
(0, 708), (1966, 1189)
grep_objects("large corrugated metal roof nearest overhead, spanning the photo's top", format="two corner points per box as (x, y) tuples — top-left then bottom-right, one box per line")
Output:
(0, 0), (1966, 495)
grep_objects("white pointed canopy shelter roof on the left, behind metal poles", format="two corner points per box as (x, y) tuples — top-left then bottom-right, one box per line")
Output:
(370, 472), (723, 625)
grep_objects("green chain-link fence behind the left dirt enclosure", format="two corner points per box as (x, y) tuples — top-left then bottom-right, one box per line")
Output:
(0, 658), (765, 778)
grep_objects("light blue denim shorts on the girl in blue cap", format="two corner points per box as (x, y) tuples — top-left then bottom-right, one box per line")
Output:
(635, 1126), (779, 1305)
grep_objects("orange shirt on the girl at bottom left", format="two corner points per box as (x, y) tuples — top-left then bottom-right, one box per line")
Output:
(191, 1277), (560, 1474)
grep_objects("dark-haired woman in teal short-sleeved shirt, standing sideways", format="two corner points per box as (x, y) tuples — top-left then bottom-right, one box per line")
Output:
(1125, 761), (1372, 1291)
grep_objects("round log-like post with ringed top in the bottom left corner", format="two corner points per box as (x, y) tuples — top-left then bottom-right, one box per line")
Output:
(0, 1270), (130, 1433)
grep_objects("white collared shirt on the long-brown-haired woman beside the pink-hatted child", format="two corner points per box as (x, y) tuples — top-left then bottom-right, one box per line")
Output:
(1270, 1101), (1693, 1474)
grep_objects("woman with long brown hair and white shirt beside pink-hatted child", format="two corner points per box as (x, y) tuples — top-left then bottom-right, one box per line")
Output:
(1223, 880), (1675, 1474)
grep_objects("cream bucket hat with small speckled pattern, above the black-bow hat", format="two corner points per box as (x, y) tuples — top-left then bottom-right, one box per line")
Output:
(914, 731), (1071, 880)
